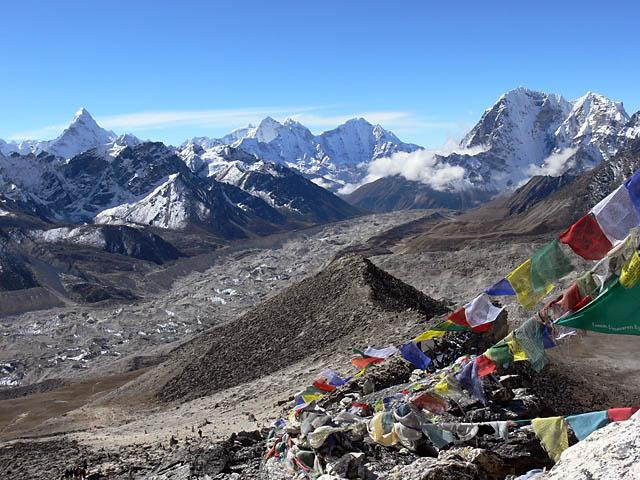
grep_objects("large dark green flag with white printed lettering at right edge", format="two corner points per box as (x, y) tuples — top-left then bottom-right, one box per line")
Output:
(557, 277), (640, 335)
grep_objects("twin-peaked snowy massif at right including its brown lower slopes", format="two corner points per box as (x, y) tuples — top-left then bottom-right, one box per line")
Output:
(345, 88), (640, 211)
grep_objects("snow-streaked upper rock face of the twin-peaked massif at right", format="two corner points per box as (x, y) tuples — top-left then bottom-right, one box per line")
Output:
(444, 88), (629, 190)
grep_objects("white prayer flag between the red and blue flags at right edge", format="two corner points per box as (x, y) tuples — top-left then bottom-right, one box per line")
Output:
(591, 185), (640, 244)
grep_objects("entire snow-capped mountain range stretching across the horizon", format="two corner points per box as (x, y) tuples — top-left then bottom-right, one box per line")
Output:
(0, 88), (640, 227)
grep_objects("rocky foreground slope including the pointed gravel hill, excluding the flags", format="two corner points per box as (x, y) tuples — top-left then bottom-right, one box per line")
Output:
(0, 231), (638, 480)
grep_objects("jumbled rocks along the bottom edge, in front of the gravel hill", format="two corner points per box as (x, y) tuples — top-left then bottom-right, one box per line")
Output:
(0, 317), (640, 480)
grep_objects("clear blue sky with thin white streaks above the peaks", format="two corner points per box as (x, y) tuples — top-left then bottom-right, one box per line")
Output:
(0, 0), (640, 147)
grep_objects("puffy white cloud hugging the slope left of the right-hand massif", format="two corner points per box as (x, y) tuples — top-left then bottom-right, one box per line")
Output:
(339, 140), (486, 194)
